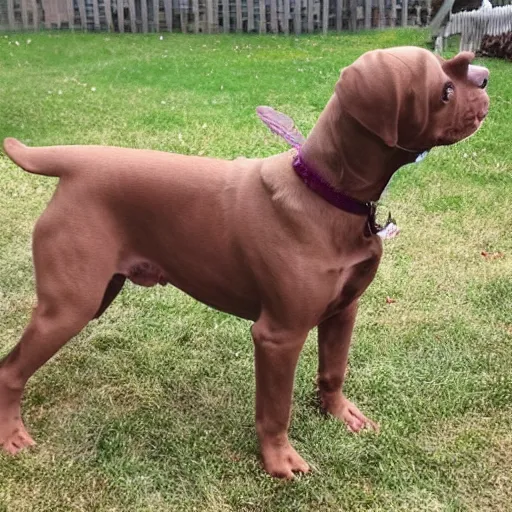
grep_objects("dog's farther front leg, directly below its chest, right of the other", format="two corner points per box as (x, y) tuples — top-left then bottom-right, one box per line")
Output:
(317, 300), (378, 432)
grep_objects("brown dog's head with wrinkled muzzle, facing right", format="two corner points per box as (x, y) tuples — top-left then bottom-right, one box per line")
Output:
(335, 47), (489, 151)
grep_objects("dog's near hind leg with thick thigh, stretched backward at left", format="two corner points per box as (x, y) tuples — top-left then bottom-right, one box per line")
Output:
(0, 216), (115, 454)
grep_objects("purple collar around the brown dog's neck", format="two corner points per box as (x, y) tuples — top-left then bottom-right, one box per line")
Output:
(292, 150), (380, 234)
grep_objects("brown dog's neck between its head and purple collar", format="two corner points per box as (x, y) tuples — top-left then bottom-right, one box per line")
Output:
(301, 95), (417, 201)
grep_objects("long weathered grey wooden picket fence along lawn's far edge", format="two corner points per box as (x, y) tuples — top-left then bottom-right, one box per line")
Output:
(0, 0), (431, 34)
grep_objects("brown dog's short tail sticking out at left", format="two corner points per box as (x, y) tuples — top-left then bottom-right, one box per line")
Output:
(4, 137), (66, 177)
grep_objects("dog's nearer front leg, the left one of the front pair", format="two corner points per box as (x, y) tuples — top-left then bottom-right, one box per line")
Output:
(252, 320), (309, 479)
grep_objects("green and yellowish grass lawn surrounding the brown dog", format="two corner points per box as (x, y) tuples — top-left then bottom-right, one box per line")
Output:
(0, 31), (512, 512)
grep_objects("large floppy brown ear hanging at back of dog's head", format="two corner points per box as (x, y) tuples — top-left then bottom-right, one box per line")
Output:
(335, 50), (411, 147)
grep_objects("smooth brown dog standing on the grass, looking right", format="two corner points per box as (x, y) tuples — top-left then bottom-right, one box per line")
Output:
(0, 47), (489, 478)
